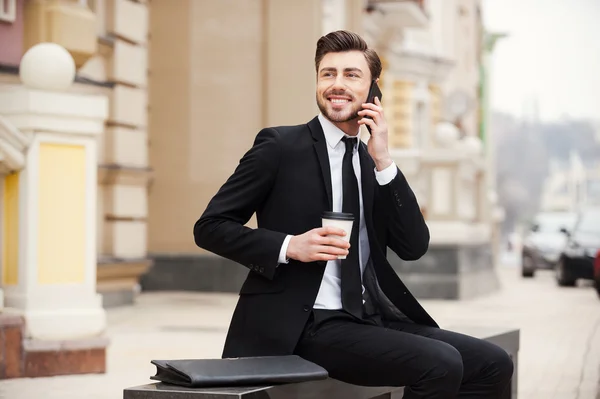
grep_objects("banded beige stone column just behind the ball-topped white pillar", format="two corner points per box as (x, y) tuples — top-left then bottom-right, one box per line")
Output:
(95, 0), (151, 308)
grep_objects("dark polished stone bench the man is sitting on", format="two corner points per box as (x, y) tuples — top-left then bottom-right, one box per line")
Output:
(123, 326), (519, 399)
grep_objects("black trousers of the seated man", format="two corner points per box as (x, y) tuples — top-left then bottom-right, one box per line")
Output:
(295, 310), (513, 399)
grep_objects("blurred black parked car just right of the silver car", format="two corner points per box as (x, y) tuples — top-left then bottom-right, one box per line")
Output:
(555, 207), (600, 286)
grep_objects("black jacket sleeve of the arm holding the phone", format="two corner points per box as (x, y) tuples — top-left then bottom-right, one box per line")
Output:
(378, 169), (429, 260)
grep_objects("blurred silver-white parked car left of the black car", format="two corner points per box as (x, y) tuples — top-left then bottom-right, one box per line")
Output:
(521, 211), (577, 277)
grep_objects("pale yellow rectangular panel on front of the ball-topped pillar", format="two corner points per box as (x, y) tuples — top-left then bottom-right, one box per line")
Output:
(37, 143), (87, 284)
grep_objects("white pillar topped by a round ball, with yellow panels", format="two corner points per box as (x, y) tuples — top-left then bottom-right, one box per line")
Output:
(0, 43), (108, 377)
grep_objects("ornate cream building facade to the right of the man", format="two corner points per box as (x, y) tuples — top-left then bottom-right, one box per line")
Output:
(366, 0), (499, 298)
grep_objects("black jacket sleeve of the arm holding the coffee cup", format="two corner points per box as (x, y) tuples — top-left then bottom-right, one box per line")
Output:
(194, 128), (286, 279)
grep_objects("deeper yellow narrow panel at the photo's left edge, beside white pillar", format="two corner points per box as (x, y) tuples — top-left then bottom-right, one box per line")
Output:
(2, 173), (19, 285)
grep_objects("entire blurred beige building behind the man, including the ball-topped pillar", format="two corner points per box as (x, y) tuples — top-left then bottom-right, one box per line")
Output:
(0, 0), (502, 375)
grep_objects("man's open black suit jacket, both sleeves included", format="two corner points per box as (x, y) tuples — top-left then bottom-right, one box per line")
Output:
(194, 118), (437, 357)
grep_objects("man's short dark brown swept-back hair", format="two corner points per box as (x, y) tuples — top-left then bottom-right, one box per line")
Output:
(315, 30), (381, 79)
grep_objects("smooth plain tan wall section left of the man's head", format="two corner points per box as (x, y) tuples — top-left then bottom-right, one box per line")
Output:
(148, 0), (322, 254)
